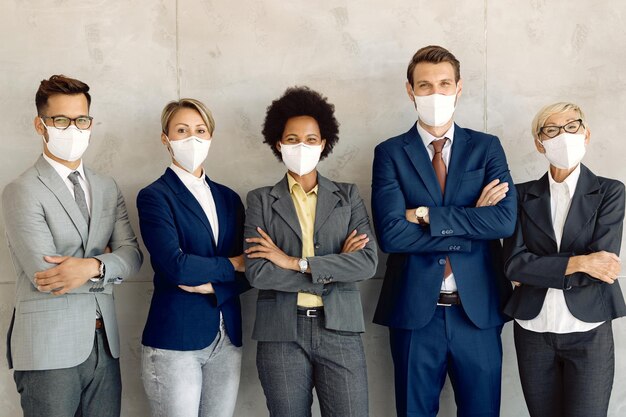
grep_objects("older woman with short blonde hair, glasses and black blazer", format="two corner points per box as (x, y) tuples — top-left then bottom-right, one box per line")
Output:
(504, 103), (626, 417)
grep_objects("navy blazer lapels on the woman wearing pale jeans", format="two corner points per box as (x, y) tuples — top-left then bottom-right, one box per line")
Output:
(162, 168), (224, 248)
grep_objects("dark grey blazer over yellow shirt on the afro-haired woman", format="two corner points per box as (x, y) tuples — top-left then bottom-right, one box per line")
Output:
(244, 174), (378, 341)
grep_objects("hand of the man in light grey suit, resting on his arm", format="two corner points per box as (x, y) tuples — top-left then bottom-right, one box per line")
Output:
(35, 256), (100, 295)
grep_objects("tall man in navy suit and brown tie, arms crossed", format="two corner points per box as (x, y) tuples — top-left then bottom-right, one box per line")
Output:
(372, 46), (516, 417)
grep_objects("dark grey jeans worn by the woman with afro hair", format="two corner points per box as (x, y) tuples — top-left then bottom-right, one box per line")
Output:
(257, 316), (369, 417)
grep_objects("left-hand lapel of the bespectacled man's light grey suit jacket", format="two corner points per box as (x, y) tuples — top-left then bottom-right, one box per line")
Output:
(35, 156), (89, 248)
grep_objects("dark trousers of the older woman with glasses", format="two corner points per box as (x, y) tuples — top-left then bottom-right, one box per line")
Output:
(514, 321), (615, 417)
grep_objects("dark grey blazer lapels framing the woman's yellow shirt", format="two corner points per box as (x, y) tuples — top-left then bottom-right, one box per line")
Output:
(270, 172), (341, 241)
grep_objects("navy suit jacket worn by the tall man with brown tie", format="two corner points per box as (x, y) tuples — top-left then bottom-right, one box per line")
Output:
(372, 125), (516, 329)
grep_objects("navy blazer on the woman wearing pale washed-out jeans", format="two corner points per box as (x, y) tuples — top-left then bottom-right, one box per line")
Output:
(137, 168), (248, 350)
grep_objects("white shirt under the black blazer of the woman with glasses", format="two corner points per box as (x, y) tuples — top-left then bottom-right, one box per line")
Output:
(516, 164), (604, 334)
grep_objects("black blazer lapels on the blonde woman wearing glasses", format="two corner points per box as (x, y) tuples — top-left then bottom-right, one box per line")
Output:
(520, 164), (603, 252)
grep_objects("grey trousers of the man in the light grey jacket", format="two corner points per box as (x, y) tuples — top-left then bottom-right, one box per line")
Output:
(13, 329), (122, 417)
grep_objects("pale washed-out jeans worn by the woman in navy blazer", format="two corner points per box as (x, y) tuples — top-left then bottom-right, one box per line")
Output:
(141, 325), (241, 417)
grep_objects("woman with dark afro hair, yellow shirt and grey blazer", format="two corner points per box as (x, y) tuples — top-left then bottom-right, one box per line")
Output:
(244, 87), (378, 417)
